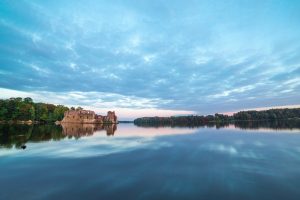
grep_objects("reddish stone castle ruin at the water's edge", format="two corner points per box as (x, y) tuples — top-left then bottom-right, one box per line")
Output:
(61, 110), (118, 124)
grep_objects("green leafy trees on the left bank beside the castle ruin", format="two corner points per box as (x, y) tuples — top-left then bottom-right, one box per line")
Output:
(0, 97), (69, 122)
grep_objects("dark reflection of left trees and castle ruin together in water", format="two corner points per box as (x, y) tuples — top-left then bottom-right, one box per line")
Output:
(0, 124), (117, 148)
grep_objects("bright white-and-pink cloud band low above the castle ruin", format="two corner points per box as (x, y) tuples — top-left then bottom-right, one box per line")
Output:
(0, 88), (195, 120)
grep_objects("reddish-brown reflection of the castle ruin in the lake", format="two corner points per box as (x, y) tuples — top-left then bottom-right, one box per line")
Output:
(61, 123), (117, 138)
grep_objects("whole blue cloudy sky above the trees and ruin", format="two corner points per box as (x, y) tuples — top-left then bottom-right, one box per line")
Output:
(0, 0), (300, 120)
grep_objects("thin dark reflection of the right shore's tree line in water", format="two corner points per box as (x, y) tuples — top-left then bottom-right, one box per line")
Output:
(135, 120), (300, 130)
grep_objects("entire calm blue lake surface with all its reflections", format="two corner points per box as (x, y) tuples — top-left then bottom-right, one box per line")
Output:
(0, 121), (300, 200)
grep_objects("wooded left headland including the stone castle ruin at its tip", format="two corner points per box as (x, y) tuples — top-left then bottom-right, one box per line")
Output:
(0, 97), (118, 124)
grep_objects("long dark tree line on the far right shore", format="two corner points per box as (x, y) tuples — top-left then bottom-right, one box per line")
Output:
(134, 108), (300, 125)
